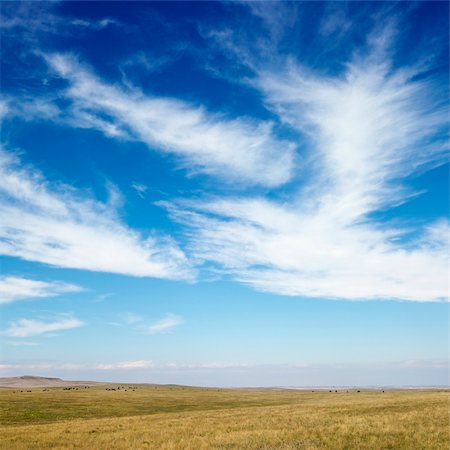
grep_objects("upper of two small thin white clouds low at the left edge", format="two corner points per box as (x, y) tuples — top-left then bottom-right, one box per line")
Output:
(0, 276), (83, 304)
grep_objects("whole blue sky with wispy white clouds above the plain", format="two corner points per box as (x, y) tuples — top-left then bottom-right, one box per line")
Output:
(0, 1), (450, 386)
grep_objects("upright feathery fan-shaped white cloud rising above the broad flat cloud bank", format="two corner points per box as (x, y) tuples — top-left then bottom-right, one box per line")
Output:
(259, 60), (446, 221)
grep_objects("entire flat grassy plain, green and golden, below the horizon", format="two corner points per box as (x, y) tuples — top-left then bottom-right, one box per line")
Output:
(0, 384), (450, 450)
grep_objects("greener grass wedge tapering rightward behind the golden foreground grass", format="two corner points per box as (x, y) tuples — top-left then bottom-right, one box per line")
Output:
(0, 385), (314, 425)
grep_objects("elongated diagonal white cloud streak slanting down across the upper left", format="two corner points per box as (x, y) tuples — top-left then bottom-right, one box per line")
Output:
(46, 54), (294, 186)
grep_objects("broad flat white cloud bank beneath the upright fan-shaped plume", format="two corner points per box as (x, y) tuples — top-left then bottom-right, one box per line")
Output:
(166, 199), (448, 301)
